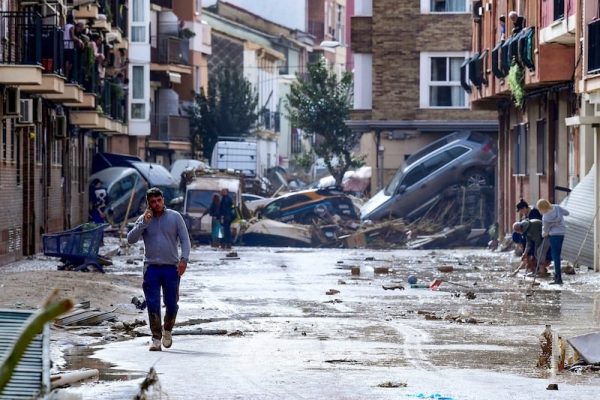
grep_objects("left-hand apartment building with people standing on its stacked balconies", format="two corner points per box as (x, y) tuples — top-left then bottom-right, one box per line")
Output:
(0, 0), (127, 264)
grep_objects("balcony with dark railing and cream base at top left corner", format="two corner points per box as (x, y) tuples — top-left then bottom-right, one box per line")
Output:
(0, 12), (42, 85)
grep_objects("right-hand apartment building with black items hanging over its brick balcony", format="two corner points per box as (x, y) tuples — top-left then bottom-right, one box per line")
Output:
(461, 0), (580, 250)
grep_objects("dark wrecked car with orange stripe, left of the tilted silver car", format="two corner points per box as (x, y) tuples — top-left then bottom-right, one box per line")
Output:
(258, 189), (358, 224)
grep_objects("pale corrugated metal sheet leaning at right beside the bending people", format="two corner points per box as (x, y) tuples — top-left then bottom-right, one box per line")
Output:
(561, 166), (596, 266)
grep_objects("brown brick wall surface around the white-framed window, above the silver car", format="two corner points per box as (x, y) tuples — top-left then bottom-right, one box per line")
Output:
(372, 0), (496, 120)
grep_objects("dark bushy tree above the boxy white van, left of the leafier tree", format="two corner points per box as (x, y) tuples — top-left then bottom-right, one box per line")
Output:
(186, 65), (258, 158)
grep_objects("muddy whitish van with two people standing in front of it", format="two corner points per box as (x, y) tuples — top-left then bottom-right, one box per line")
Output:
(182, 174), (242, 242)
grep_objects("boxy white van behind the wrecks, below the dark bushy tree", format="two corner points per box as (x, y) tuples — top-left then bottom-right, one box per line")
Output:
(210, 141), (258, 175)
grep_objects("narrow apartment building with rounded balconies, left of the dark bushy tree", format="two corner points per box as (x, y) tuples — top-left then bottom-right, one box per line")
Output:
(145, 0), (212, 167)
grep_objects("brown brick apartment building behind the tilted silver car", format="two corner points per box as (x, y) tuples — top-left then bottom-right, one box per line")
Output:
(349, 0), (497, 192)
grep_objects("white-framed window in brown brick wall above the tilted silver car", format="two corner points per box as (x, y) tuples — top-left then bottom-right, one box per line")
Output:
(420, 53), (467, 108)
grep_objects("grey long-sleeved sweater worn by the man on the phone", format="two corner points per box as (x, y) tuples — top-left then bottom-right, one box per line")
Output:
(127, 209), (191, 265)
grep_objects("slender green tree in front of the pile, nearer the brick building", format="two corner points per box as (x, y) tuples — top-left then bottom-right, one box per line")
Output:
(285, 58), (361, 186)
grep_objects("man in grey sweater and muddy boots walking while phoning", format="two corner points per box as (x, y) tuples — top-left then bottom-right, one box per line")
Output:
(127, 188), (191, 351)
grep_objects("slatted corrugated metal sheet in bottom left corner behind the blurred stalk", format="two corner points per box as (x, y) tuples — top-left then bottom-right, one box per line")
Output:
(0, 310), (50, 400)
